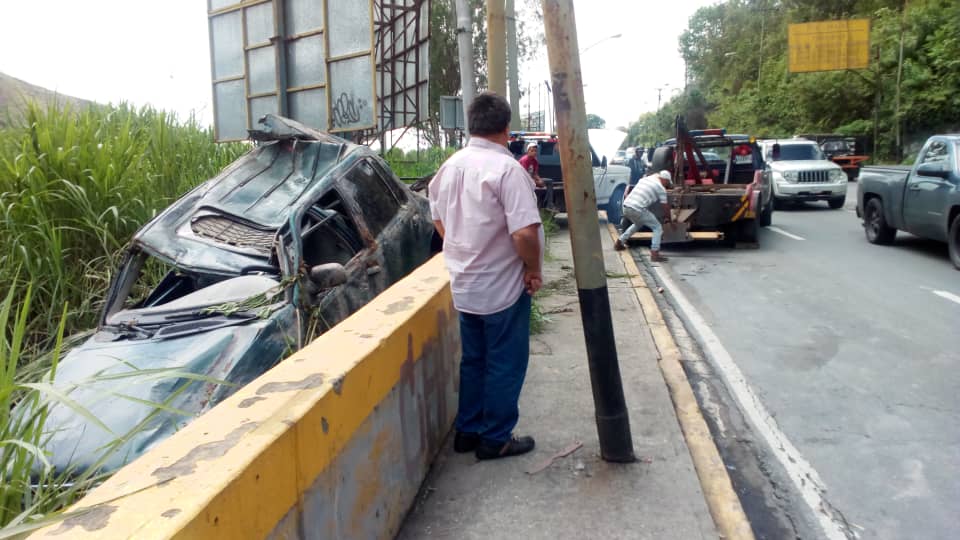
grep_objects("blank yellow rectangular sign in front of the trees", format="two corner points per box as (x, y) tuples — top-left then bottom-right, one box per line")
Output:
(787, 19), (870, 73)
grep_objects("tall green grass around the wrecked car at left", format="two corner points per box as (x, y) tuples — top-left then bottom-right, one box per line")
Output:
(0, 104), (247, 537)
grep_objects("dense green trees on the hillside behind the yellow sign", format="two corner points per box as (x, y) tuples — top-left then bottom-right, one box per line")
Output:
(630, 0), (960, 161)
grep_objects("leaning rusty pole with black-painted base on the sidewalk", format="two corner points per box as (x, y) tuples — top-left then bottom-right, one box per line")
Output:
(543, 0), (636, 463)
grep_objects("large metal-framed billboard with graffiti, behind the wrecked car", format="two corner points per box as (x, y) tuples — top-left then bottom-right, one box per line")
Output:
(207, 0), (430, 146)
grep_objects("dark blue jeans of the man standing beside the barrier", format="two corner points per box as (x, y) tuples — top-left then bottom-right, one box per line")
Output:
(456, 291), (530, 445)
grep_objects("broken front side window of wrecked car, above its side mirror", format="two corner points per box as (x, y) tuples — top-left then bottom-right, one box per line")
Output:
(300, 190), (364, 267)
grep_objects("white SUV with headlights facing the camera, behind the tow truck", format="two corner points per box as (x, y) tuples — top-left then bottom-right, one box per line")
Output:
(759, 139), (847, 209)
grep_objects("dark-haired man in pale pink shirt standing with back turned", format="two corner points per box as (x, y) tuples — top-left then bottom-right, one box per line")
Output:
(430, 92), (543, 459)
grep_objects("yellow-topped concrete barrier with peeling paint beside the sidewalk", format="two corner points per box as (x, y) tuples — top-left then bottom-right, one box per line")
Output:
(34, 256), (460, 539)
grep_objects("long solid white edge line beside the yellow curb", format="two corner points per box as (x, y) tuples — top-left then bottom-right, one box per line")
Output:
(653, 262), (852, 540)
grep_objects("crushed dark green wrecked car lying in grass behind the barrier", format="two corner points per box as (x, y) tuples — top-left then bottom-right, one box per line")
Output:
(34, 115), (434, 471)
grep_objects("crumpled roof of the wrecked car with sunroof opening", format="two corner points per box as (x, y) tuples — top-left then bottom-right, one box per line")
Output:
(134, 115), (373, 273)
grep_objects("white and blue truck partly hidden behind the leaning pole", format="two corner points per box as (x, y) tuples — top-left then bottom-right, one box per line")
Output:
(509, 129), (630, 223)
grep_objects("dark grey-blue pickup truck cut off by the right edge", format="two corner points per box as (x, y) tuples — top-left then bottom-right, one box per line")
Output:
(857, 135), (960, 270)
